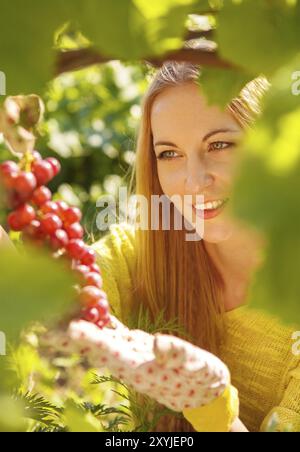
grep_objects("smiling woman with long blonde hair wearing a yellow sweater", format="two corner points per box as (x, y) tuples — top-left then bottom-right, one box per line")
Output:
(0, 62), (300, 431)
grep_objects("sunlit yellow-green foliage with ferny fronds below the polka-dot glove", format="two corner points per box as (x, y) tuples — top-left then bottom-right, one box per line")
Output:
(0, 306), (180, 432)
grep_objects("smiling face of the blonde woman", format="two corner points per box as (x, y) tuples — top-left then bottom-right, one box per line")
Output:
(151, 82), (243, 243)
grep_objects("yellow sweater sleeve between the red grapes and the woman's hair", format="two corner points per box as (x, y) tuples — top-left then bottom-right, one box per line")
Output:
(92, 223), (135, 322)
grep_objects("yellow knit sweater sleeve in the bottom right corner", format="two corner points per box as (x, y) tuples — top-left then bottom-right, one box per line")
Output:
(261, 354), (300, 432)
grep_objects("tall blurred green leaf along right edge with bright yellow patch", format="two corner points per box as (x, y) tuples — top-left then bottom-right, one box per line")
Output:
(232, 56), (300, 323)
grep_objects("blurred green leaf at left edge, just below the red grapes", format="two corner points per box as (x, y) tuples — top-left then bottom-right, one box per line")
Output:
(0, 250), (75, 338)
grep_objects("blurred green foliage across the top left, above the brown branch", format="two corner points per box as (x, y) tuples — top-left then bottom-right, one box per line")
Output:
(0, 0), (199, 94)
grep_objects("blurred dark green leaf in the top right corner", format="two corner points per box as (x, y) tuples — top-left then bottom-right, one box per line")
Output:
(216, 0), (300, 75)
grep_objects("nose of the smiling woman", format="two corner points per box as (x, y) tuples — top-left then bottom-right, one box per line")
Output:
(185, 162), (213, 194)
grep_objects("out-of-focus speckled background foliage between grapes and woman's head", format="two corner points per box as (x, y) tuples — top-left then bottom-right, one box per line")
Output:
(38, 62), (148, 241)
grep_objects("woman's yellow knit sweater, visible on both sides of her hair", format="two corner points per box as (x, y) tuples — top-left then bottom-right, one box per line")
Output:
(93, 223), (300, 432)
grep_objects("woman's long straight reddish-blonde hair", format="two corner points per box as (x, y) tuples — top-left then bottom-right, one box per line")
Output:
(127, 61), (268, 431)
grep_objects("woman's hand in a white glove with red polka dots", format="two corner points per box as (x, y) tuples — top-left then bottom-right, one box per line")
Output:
(43, 317), (230, 412)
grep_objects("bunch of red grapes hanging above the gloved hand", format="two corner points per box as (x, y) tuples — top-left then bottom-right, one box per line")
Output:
(0, 151), (110, 328)
